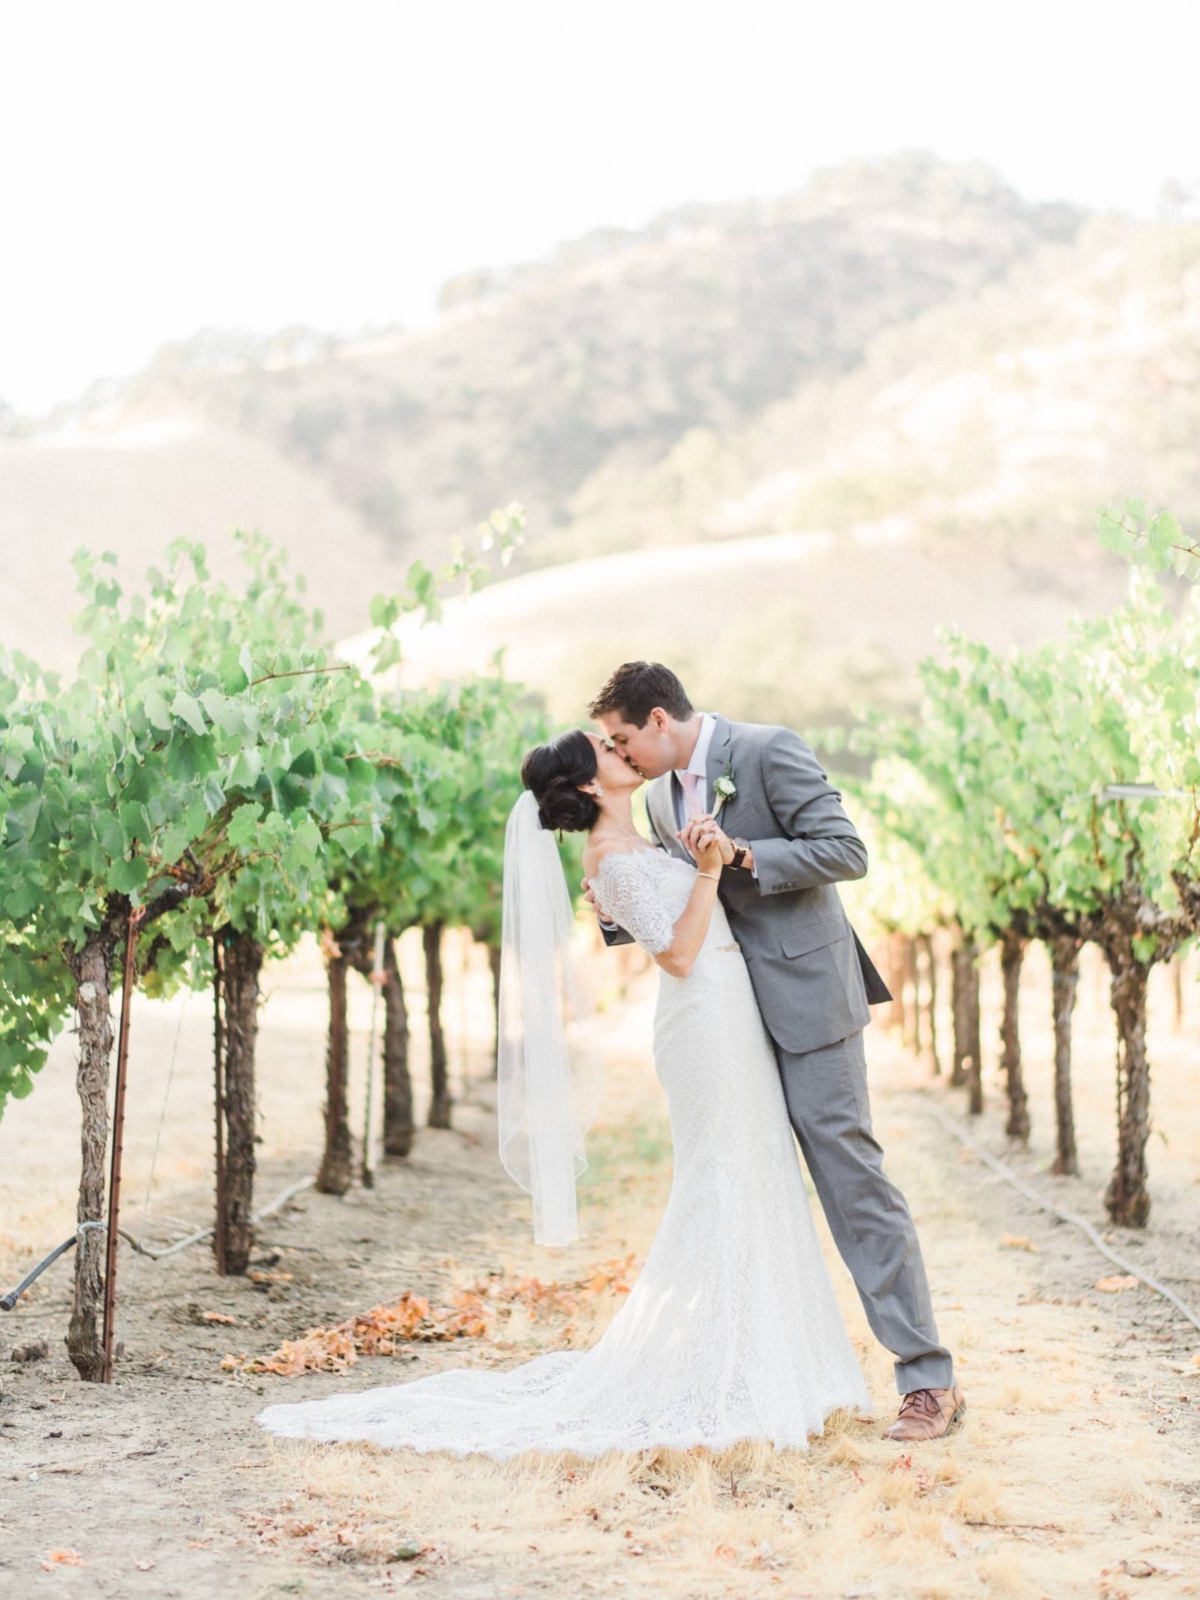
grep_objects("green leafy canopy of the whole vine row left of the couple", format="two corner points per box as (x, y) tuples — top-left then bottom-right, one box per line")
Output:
(0, 506), (533, 1110)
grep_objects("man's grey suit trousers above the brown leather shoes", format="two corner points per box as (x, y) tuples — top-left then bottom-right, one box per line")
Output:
(776, 1029), (954, 1395)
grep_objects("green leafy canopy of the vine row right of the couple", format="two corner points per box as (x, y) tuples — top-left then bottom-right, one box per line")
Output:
(854, 550), (1200, 962)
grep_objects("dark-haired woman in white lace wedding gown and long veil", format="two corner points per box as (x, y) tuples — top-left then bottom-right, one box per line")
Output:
(258, 730), (872, 1459)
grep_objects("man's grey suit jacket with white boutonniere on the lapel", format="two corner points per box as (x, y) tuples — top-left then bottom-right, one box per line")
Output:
(605, 717), (891, 1054)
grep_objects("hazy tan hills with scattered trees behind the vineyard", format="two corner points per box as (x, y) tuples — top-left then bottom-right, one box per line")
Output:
(0, 155), (1200, 722)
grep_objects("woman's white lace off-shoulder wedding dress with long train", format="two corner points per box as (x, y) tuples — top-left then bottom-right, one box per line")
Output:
(258, 848), (870, 1459)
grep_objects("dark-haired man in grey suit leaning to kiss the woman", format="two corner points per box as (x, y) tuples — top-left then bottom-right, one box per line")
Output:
(589, 661), (965, 1443)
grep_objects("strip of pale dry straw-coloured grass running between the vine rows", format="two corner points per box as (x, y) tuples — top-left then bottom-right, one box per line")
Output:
(256, 985), (1200, 1600)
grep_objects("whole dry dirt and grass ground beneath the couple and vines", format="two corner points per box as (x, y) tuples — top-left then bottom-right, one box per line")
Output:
(0, 949), (1200, 1600)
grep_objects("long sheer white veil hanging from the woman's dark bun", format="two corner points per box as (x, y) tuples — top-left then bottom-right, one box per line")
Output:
(498, 789), (602, 1245)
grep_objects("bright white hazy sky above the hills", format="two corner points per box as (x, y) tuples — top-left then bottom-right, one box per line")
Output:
(0, 0), (1200, 411)
